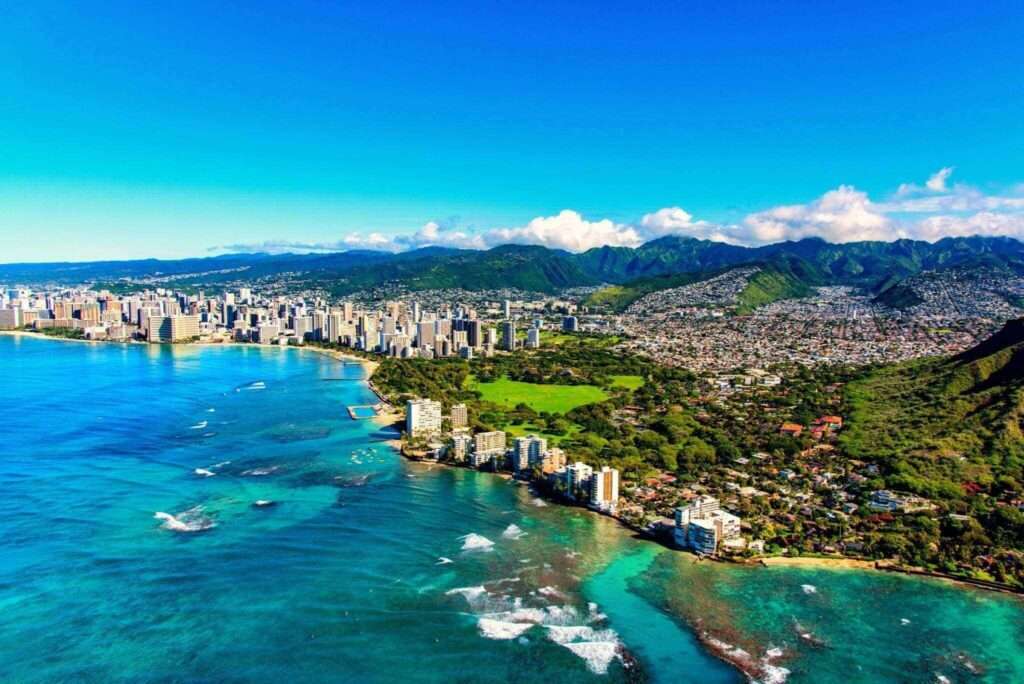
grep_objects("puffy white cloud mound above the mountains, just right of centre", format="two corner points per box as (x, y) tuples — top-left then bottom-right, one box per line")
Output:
(483, 209), (644, 252)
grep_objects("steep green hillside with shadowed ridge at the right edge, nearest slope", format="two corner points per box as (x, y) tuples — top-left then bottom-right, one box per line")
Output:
(842, 318), (1024, 499)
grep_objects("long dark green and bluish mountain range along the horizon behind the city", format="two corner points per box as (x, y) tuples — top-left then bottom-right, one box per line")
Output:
(6, 236), (1024, 294)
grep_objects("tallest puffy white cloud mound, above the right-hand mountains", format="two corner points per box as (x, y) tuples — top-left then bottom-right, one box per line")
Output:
(743, 185), (902, 244)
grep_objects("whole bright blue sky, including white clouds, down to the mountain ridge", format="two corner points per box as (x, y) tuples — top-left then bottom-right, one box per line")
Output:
(0, 0), (1024, 261)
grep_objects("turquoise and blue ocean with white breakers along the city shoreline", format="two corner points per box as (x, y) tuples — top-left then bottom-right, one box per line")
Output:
(0, 337), (1024, 683)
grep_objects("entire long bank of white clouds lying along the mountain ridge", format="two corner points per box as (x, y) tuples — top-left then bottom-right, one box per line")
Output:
(212, 166), (1024, 252)
